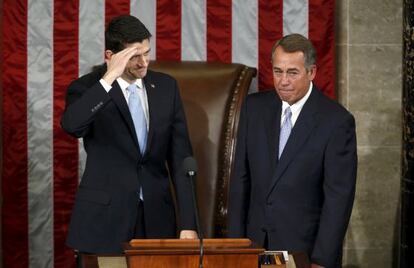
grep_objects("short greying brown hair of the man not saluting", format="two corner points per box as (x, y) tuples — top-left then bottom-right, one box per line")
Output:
(272, 33), (316, 69)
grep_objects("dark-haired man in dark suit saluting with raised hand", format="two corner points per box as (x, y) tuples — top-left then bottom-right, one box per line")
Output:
(61, 16), (197, 253)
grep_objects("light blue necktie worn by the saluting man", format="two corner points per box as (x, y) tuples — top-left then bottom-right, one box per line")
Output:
(127, 84), (148, 154)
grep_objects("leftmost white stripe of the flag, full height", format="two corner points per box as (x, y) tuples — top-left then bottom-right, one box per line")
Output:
(27, 0), (53, 267)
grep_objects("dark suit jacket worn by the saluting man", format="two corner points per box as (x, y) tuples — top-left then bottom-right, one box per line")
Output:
(61, 66), (195, 253)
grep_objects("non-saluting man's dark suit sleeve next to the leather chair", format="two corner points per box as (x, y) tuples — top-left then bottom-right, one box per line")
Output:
(227, 100), (250, 237)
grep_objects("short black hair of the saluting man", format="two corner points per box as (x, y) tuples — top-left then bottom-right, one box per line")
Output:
(105, 15), (151, 53)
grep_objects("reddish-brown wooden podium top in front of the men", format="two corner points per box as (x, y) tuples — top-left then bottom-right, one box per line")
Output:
(124, 239), (264, 268)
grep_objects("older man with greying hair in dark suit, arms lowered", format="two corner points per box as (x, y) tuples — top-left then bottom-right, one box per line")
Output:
(228, 34), (357, 267)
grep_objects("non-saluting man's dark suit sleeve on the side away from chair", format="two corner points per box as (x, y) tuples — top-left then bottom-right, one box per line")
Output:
(311, 113), (357, 267)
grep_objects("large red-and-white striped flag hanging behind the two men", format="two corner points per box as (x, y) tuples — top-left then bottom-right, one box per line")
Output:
(1, 0), (335, 268)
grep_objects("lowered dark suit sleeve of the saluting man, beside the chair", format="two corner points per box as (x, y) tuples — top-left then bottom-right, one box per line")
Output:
(168, 81), (196, 230)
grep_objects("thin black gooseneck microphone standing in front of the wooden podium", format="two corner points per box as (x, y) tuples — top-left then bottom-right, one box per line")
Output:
(183, 156), (204, 268)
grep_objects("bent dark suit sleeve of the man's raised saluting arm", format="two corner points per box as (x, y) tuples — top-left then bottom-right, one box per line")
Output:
(61, 79), (110, 138)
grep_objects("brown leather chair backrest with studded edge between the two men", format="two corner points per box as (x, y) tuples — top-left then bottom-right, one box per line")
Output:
(150, 61), (256, 237)
